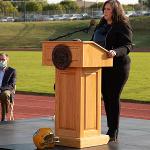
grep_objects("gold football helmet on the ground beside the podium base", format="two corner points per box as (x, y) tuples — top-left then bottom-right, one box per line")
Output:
(33, 128), (59, 149)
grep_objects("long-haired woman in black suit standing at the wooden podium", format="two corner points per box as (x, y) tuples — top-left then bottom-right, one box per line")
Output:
(92, 0), (132, 141)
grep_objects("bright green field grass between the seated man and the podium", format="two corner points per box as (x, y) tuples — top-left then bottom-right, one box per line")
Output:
(3, 51), (55, 93)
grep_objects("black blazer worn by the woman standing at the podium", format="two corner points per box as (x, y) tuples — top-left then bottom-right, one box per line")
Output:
(92, 22), (132, 66)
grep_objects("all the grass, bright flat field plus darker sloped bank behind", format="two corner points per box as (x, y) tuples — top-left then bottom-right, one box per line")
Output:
(0, 17), (150, 102)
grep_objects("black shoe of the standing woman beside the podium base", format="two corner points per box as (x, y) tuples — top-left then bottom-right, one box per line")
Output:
(106, 129), (118, 142)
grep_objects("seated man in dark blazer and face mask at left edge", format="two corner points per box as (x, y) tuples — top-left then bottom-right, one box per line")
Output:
(0, 53), (16, 121)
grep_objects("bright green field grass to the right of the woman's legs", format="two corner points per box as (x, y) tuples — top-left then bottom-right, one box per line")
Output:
(121, 52), (150, 102)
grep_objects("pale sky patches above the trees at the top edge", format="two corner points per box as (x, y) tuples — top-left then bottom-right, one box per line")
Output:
(48, 0), (138, 4)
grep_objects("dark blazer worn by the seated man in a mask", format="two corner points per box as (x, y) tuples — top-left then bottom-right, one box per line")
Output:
(0, 67), (16, 91)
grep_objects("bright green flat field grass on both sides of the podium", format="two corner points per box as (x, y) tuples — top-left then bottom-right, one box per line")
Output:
(1, 51), (150, 102)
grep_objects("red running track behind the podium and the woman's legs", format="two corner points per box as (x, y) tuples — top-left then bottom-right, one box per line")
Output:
(1, 94), (150, 120)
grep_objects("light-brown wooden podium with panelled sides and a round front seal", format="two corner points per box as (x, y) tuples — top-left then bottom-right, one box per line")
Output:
(42, 41), (113, 148)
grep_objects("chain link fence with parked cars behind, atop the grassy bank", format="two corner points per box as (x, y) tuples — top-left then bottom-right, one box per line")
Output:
(0, 8), (150, 22)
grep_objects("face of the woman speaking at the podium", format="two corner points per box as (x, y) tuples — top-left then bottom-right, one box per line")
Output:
(104, 3), (113, 24)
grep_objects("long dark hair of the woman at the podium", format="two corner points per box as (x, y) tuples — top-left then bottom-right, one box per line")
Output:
(100, 0), (129, 24)
